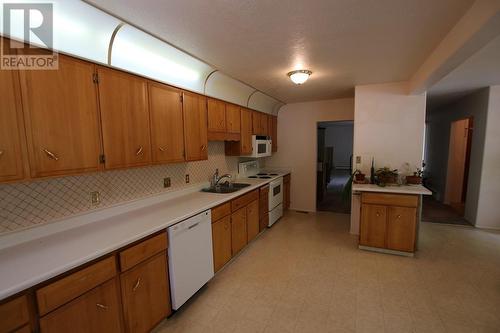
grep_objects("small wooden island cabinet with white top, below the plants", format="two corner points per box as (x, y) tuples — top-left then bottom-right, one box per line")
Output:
(351, 184), (432, 256)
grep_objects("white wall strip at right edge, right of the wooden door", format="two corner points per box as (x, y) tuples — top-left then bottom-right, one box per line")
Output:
(476, 86), (500, 229)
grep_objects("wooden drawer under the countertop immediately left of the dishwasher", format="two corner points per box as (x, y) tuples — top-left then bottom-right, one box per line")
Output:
(120, 232), (167, 272)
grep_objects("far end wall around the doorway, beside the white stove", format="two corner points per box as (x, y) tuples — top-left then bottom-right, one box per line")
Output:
(266, 98), (354, 212)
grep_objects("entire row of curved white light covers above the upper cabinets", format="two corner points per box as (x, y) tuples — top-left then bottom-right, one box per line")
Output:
(0, 0), (284, 114)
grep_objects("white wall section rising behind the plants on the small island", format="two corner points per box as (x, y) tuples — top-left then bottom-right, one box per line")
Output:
(351, 82), (426, 234)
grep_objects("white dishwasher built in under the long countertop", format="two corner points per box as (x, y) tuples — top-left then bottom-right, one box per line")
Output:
(167, 210), (214, 310)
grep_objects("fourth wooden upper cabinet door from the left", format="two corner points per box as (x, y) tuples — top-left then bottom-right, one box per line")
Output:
(148, 82), (184, 163)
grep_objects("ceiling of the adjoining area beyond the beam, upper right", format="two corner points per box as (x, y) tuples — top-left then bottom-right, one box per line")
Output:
(428, 36), (500, 108)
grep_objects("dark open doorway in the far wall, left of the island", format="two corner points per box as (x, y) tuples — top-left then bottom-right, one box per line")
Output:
(316, 121), (354, 214)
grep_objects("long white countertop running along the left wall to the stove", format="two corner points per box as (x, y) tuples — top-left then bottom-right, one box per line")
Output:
(0, 172), (288, 300)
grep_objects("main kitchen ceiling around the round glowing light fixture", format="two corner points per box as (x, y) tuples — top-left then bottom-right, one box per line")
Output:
(86, 0), (473, 103)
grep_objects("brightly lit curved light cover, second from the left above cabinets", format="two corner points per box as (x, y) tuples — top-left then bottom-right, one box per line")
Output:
(111, 25), (213, 93)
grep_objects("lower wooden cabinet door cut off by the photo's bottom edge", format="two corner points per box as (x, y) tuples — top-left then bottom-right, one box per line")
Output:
(40, 279), (122, 333)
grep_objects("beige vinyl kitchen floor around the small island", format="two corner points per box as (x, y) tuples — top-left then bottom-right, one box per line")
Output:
(155, 212), (500, 333)
